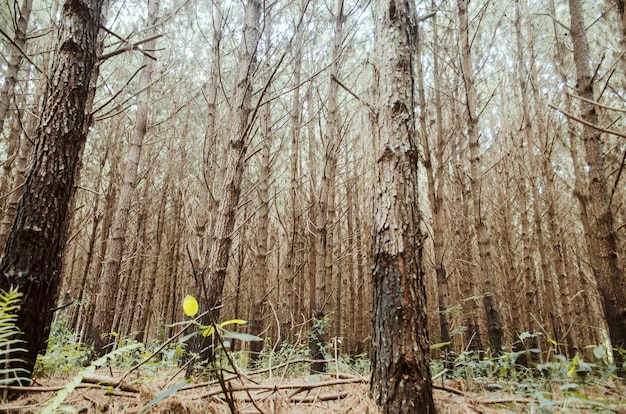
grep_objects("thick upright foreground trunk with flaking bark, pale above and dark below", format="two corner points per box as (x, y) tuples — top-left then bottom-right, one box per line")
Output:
(371, 0), (435, 413)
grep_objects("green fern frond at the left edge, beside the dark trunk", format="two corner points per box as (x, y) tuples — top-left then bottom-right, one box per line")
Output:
(0, 288), (30, 385)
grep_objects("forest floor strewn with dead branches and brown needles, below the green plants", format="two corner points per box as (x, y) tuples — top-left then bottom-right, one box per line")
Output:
(0, 369), (626, 414)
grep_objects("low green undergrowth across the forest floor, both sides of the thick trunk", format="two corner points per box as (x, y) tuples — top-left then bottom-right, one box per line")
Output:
(22, 302), (626, 414)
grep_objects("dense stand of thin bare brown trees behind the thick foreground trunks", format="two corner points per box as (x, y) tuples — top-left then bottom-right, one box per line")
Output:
(0, 0), (626, 384)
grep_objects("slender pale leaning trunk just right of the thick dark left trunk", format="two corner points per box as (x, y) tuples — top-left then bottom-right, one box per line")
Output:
(87, 0), (160, 355)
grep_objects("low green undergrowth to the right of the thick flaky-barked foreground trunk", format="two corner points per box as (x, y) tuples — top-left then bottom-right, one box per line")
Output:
(431, 333), (626, 414)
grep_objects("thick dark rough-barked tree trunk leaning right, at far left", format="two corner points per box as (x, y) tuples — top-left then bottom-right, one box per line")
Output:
(0, 0), (108, 380)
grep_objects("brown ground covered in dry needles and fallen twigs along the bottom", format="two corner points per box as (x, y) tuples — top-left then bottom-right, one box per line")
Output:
(0, 374), (626, 414)
